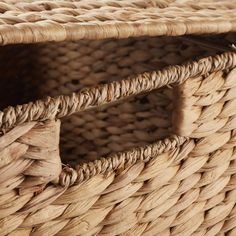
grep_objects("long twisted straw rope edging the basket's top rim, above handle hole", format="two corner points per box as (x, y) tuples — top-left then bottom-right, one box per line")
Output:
(0, 52), (236, 133)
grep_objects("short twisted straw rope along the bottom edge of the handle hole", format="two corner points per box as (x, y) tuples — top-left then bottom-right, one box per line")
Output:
(59, 136), (188, 186)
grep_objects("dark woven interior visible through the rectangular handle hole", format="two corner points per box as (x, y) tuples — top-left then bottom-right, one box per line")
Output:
(61, 88), (172, 163)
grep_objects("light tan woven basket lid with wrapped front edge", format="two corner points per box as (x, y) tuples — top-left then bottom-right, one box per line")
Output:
(0, 0), (236, 45)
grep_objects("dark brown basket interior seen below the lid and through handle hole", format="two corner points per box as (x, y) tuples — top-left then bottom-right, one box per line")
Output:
(0, 35), (231, 164)
